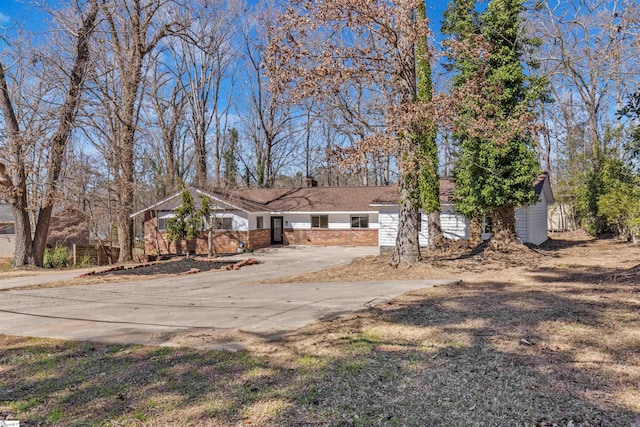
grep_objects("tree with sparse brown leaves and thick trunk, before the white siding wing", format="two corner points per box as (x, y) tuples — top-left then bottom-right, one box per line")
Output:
(267, 0), (430, 264)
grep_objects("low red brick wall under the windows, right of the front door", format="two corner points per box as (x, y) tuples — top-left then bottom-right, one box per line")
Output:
(284, 228), (378, 246)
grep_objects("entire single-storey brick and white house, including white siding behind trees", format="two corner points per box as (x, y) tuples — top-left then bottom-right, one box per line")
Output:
(132, 174), (553, 254)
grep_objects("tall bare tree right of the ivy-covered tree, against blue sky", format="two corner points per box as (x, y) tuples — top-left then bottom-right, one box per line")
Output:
(529, 0), (638, 168)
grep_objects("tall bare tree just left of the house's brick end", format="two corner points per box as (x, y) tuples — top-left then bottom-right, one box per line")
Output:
(85, 0), (183, 261)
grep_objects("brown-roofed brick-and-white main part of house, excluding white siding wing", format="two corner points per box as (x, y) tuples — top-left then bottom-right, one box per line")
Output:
(132, 187), (397, 254)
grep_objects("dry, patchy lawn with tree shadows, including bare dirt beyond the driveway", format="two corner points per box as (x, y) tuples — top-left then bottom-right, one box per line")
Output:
(0, 234), (640, 426)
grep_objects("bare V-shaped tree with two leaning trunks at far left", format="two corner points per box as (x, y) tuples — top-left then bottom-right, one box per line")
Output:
(0, 0), (99, 267)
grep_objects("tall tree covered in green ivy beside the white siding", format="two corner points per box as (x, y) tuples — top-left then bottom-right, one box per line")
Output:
(443, 0), (546, 246)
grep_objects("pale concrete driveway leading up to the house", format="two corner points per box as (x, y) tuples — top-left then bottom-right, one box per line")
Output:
(0, 247), (453, 348)
